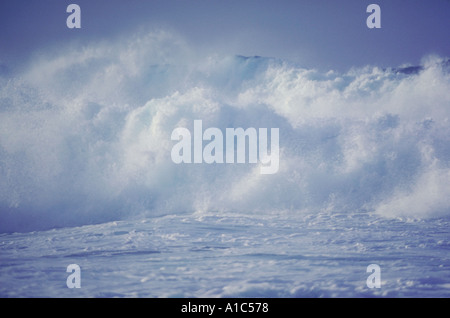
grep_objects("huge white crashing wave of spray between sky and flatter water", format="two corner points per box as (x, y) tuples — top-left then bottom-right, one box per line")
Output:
(0, 31), (450, 232)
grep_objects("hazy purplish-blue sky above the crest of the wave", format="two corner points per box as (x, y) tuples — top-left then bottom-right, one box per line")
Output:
(0, 0), (450, 70)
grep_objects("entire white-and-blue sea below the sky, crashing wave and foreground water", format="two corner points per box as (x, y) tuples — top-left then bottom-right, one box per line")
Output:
(0, 31), (450, 297)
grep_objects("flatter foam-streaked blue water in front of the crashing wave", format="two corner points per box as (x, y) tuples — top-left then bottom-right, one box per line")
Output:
(0, 213), (450, 297)
